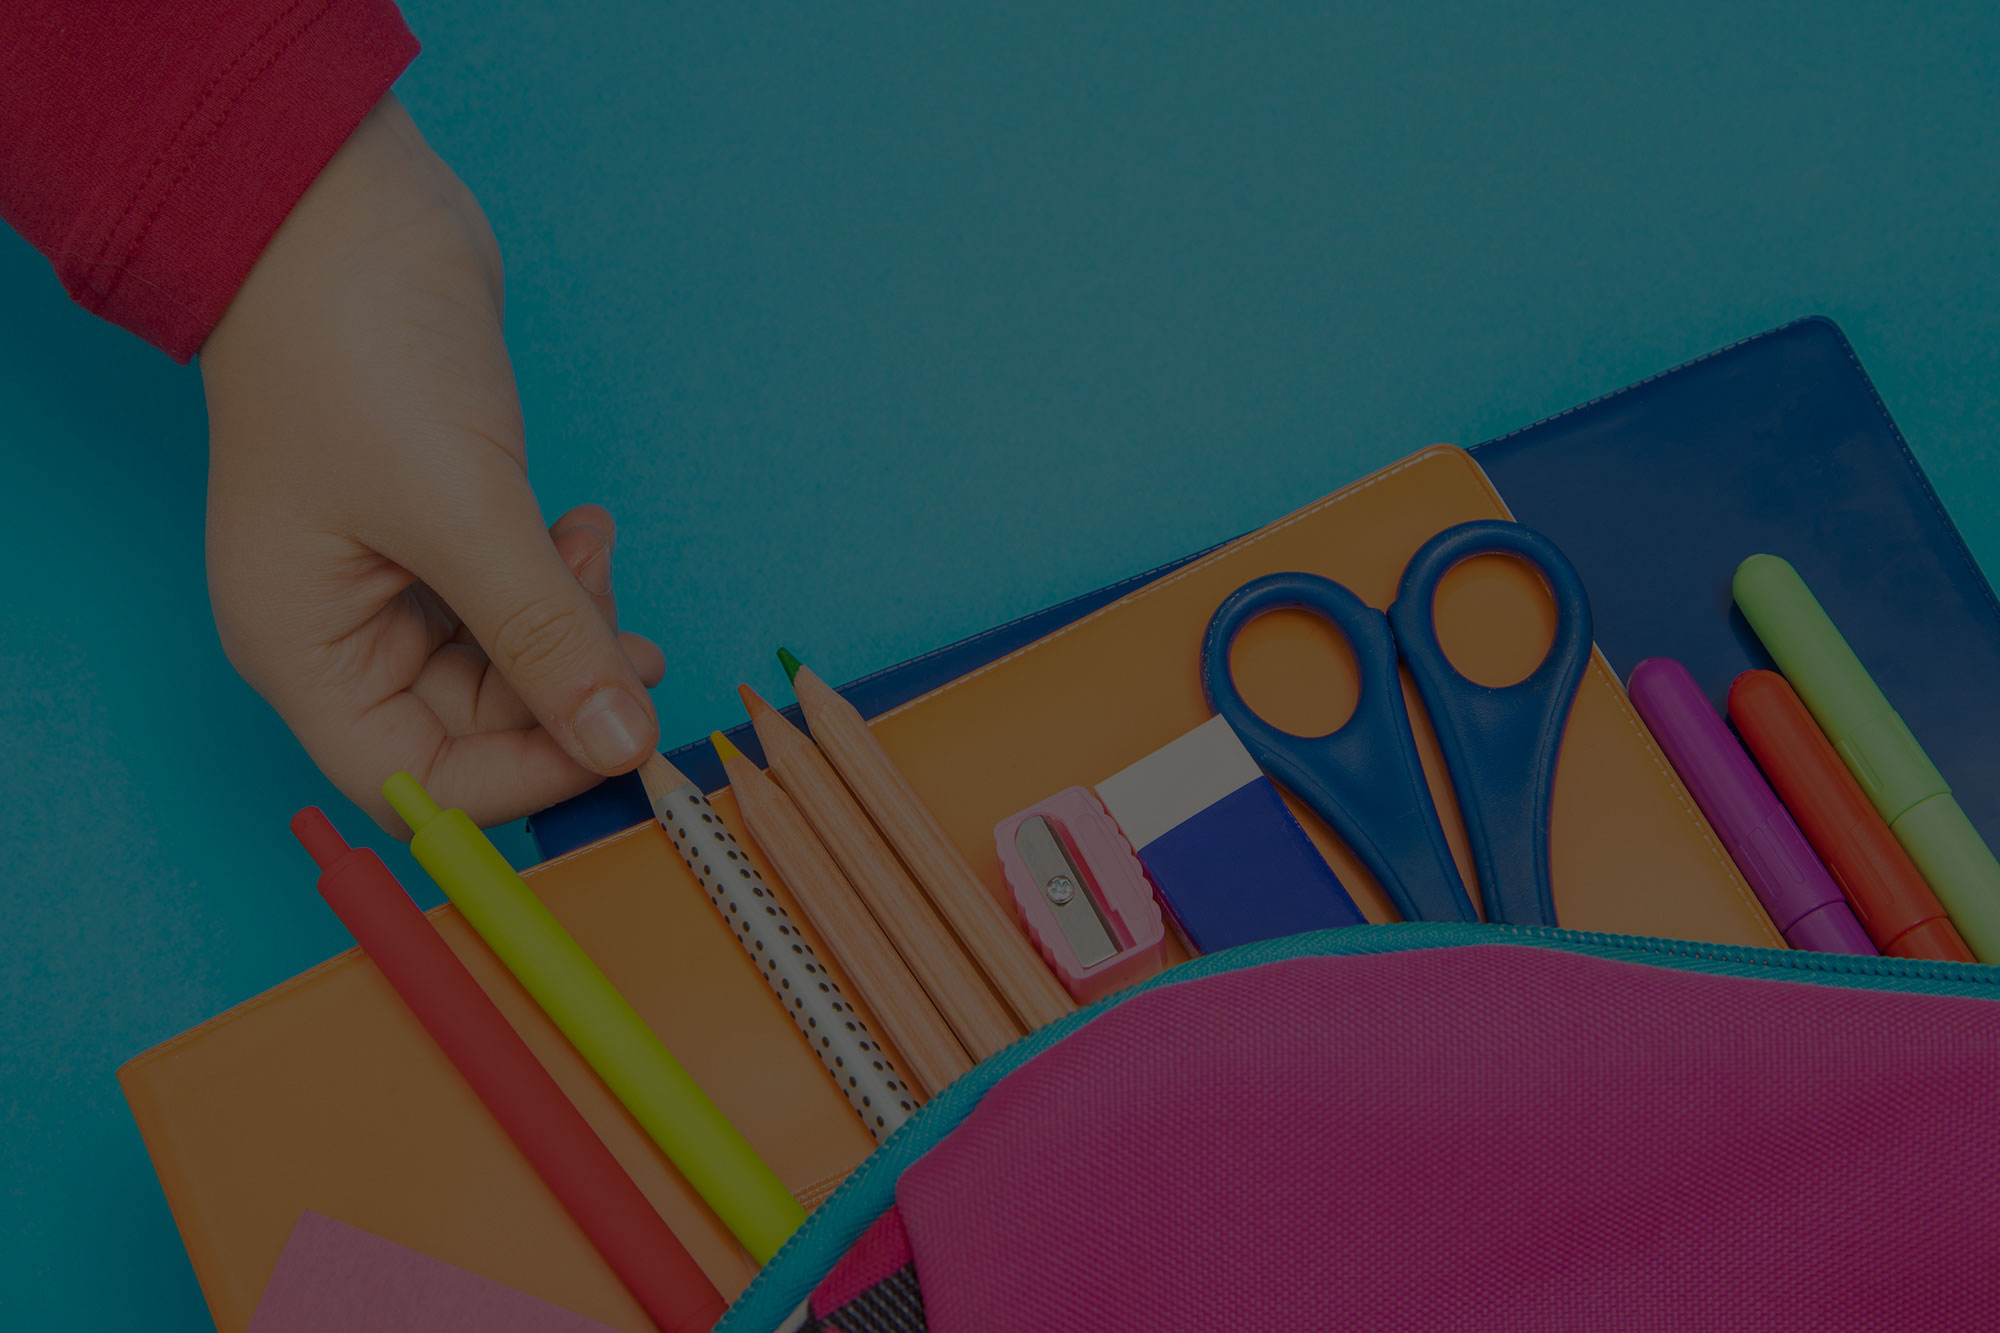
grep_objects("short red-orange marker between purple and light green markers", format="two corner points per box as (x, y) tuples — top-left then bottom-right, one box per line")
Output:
(1730, 671), (1976, 963)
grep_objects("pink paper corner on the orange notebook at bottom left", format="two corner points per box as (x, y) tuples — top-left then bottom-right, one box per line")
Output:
(250, 1213), (612, 1333)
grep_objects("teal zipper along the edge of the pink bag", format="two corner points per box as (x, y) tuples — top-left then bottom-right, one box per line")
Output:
(716, 921), (2000, 1333)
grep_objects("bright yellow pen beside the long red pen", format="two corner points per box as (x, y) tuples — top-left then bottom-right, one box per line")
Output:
(382, 773), (806, 1263)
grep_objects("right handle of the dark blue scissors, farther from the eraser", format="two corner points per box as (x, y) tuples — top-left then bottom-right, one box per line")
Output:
(1388, 518), (1590, 925)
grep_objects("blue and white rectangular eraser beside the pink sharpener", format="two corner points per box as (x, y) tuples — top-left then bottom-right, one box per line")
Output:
(1096, 717), (1364, 953)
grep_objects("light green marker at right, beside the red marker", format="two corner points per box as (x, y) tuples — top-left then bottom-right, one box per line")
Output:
(1734, 554), (2000, 963)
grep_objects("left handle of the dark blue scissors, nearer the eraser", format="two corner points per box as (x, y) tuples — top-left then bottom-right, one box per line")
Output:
(1202, 574), (1478, 921)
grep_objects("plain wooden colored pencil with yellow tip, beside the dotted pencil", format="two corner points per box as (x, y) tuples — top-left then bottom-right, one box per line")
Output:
(710, 733), (972, 1093)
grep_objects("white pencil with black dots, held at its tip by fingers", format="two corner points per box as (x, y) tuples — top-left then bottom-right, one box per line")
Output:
(638, 755), (916, 1143)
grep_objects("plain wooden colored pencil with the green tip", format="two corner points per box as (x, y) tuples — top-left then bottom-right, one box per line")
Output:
(778, 648), (1076, 1033)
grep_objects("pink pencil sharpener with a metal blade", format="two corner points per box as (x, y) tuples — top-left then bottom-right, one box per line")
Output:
(994, 787), (1166, 1003)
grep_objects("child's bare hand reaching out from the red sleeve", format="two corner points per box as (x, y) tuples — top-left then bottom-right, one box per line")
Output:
(200, 96), (664, 835)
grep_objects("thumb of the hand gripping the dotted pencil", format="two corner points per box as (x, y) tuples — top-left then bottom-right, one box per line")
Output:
(412, 502), (660, 775)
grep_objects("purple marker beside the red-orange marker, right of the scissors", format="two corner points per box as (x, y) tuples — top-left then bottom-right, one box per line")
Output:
(1626, 656), (1878, 955)
